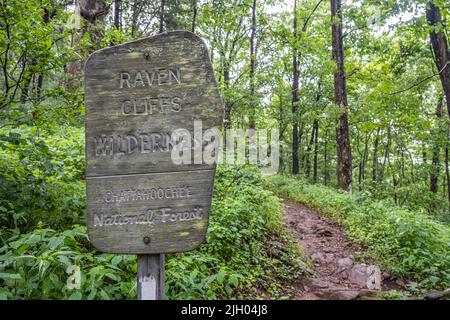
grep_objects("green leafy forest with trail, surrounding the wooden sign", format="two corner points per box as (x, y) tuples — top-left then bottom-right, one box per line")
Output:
(0, 0), (450, 300)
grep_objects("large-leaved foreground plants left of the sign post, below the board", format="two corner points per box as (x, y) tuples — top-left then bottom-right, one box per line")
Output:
(0, 226), (136, 299)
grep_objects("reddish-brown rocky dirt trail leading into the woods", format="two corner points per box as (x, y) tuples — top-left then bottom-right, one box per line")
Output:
(284, 201), (402, 300)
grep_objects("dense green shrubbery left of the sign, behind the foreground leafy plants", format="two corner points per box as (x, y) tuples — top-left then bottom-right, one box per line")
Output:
(0, 127), (84, 234)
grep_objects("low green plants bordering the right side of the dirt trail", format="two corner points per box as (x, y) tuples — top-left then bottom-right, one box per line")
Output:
(268, 176), (450, 289)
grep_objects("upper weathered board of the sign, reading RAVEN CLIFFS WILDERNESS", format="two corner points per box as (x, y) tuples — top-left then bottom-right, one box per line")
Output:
(85, 31), (223, 176)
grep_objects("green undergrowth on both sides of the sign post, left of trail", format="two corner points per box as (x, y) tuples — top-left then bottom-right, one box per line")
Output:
(0, 127), (304, 299)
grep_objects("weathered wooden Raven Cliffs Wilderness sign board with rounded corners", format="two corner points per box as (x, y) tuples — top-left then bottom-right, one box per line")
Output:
(85, 31), (222, 254)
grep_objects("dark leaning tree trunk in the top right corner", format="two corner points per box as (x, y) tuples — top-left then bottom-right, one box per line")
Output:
(427, 1), (450, 114)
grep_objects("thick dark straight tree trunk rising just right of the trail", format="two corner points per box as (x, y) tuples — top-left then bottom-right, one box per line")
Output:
(331, 0), (352, 191)
